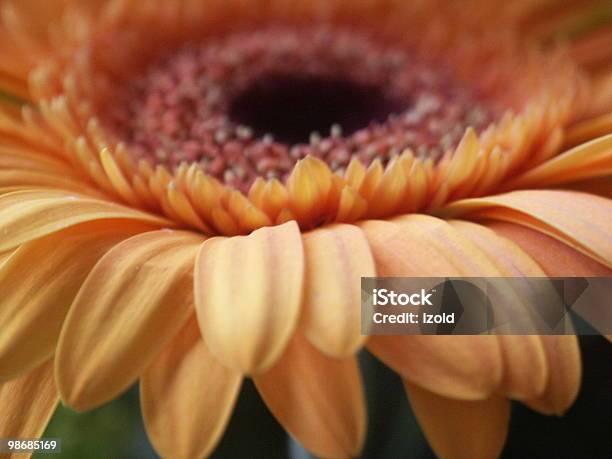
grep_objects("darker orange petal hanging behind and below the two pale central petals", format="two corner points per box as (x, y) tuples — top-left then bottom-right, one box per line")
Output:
(255, 334), (366, 458)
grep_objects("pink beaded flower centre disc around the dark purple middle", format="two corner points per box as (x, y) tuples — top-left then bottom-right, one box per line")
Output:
(103, 26), (497, 191)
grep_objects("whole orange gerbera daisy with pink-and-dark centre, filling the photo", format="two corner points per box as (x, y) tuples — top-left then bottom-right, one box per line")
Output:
(0, 0), (612, 458)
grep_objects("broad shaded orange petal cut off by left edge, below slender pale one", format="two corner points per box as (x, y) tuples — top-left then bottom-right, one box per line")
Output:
(0, 220), (150, 381)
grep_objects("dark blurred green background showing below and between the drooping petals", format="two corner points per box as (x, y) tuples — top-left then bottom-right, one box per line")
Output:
(35, 336), (612, 459)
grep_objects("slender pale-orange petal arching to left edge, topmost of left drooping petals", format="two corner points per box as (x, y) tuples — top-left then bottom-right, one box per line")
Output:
(0, 190), (171, 252)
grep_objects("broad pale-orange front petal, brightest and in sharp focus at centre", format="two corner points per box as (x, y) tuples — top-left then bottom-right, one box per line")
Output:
(195, 221), (304, 373)
